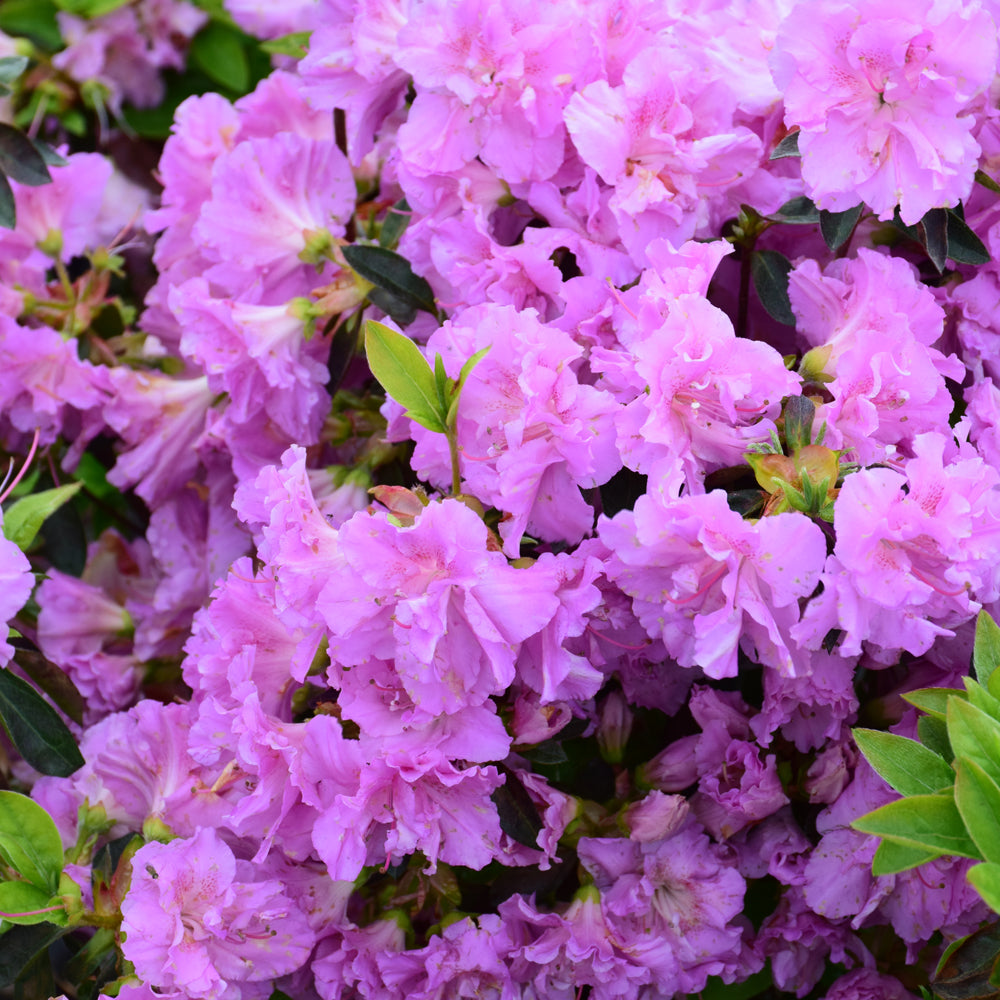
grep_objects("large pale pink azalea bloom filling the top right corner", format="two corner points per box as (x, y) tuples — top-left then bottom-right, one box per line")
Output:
(771, 0), (997, 225)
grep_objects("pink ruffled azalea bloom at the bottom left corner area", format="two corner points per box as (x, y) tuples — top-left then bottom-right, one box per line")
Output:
(122, 828), (316, 1000)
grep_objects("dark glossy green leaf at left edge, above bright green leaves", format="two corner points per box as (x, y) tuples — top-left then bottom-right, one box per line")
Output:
(0, 670), (83, 778)
